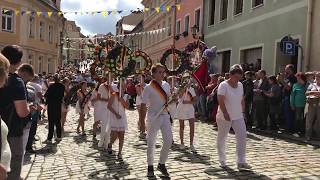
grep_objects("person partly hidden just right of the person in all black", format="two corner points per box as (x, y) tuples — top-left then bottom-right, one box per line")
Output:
(61, 77), (71, 132)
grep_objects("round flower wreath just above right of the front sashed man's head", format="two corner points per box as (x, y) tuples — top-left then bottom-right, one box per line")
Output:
(160, 49), (191, 76)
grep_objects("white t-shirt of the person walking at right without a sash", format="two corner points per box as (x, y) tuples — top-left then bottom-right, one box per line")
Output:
(217, 81), (243, 120)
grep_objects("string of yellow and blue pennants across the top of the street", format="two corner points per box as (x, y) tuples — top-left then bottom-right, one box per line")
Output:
(2, 4), (181, 17)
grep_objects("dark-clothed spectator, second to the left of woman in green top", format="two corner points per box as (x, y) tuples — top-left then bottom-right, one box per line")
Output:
(264, 76), (281, 130)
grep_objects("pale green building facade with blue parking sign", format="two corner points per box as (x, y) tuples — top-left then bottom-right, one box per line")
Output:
(204, 0), (319, 74)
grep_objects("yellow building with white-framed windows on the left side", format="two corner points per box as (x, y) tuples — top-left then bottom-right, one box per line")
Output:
(0, 0), (64, 73)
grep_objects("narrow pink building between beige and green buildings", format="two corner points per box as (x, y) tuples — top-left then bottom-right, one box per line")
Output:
(175, 0), (203, 49)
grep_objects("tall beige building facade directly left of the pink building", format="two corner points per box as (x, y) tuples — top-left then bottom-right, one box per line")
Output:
(142, 0), (174, 63)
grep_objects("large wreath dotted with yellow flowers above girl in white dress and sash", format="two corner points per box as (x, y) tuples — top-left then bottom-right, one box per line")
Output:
(103, 44), (136, 78)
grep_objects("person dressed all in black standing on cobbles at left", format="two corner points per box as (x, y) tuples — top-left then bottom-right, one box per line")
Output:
(44, 74), (64, 143)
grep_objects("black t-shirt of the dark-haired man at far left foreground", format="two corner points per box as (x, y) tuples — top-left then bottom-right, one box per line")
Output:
(0, 73), (30, 137)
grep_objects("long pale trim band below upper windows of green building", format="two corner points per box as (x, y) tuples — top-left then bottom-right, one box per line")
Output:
(206, 0), (308, 38)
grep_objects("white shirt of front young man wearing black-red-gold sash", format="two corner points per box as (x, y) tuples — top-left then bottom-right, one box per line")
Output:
(142, 81), (171, 119)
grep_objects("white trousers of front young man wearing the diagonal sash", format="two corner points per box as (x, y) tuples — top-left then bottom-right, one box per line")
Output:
(147, 115), (173, 166)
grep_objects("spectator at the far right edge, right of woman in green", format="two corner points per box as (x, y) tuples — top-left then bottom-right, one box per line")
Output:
(305, 72), (320, 140)
